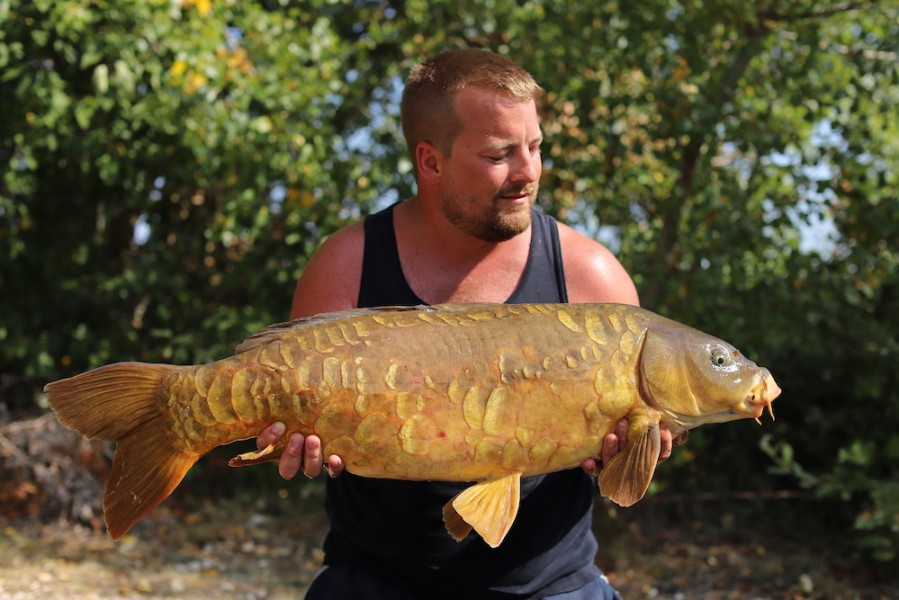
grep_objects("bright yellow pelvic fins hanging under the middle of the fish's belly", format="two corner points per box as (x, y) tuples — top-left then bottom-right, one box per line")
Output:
(443, 473), (521, 548)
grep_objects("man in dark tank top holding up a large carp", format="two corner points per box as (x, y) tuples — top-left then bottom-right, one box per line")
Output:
(257, 50), (684, 600)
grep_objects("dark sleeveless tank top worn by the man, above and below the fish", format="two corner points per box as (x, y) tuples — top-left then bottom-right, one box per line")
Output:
(325, 206), (597, 599)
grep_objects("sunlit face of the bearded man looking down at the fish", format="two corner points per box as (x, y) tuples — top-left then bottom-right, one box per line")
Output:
(442, 88), (543, 242)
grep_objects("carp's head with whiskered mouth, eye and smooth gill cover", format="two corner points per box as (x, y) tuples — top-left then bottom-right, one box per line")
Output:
(639, 320), (780, 431)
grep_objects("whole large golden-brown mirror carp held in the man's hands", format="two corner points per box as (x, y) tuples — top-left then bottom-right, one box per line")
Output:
(45, 304), (780, 546)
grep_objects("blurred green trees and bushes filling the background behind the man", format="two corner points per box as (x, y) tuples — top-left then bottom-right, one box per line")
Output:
(0, 0), (899, 564)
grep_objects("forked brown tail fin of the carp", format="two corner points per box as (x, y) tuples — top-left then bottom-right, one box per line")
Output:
(44, 363), (200, 540)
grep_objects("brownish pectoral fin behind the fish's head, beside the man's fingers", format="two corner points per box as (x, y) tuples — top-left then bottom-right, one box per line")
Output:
(599, 416), (662, 506)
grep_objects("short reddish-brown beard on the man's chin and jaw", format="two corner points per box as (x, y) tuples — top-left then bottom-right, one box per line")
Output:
(441, 185), (537, 243)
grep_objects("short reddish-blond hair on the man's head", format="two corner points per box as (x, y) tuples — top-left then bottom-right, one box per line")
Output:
(400, 50), (543, 163)
